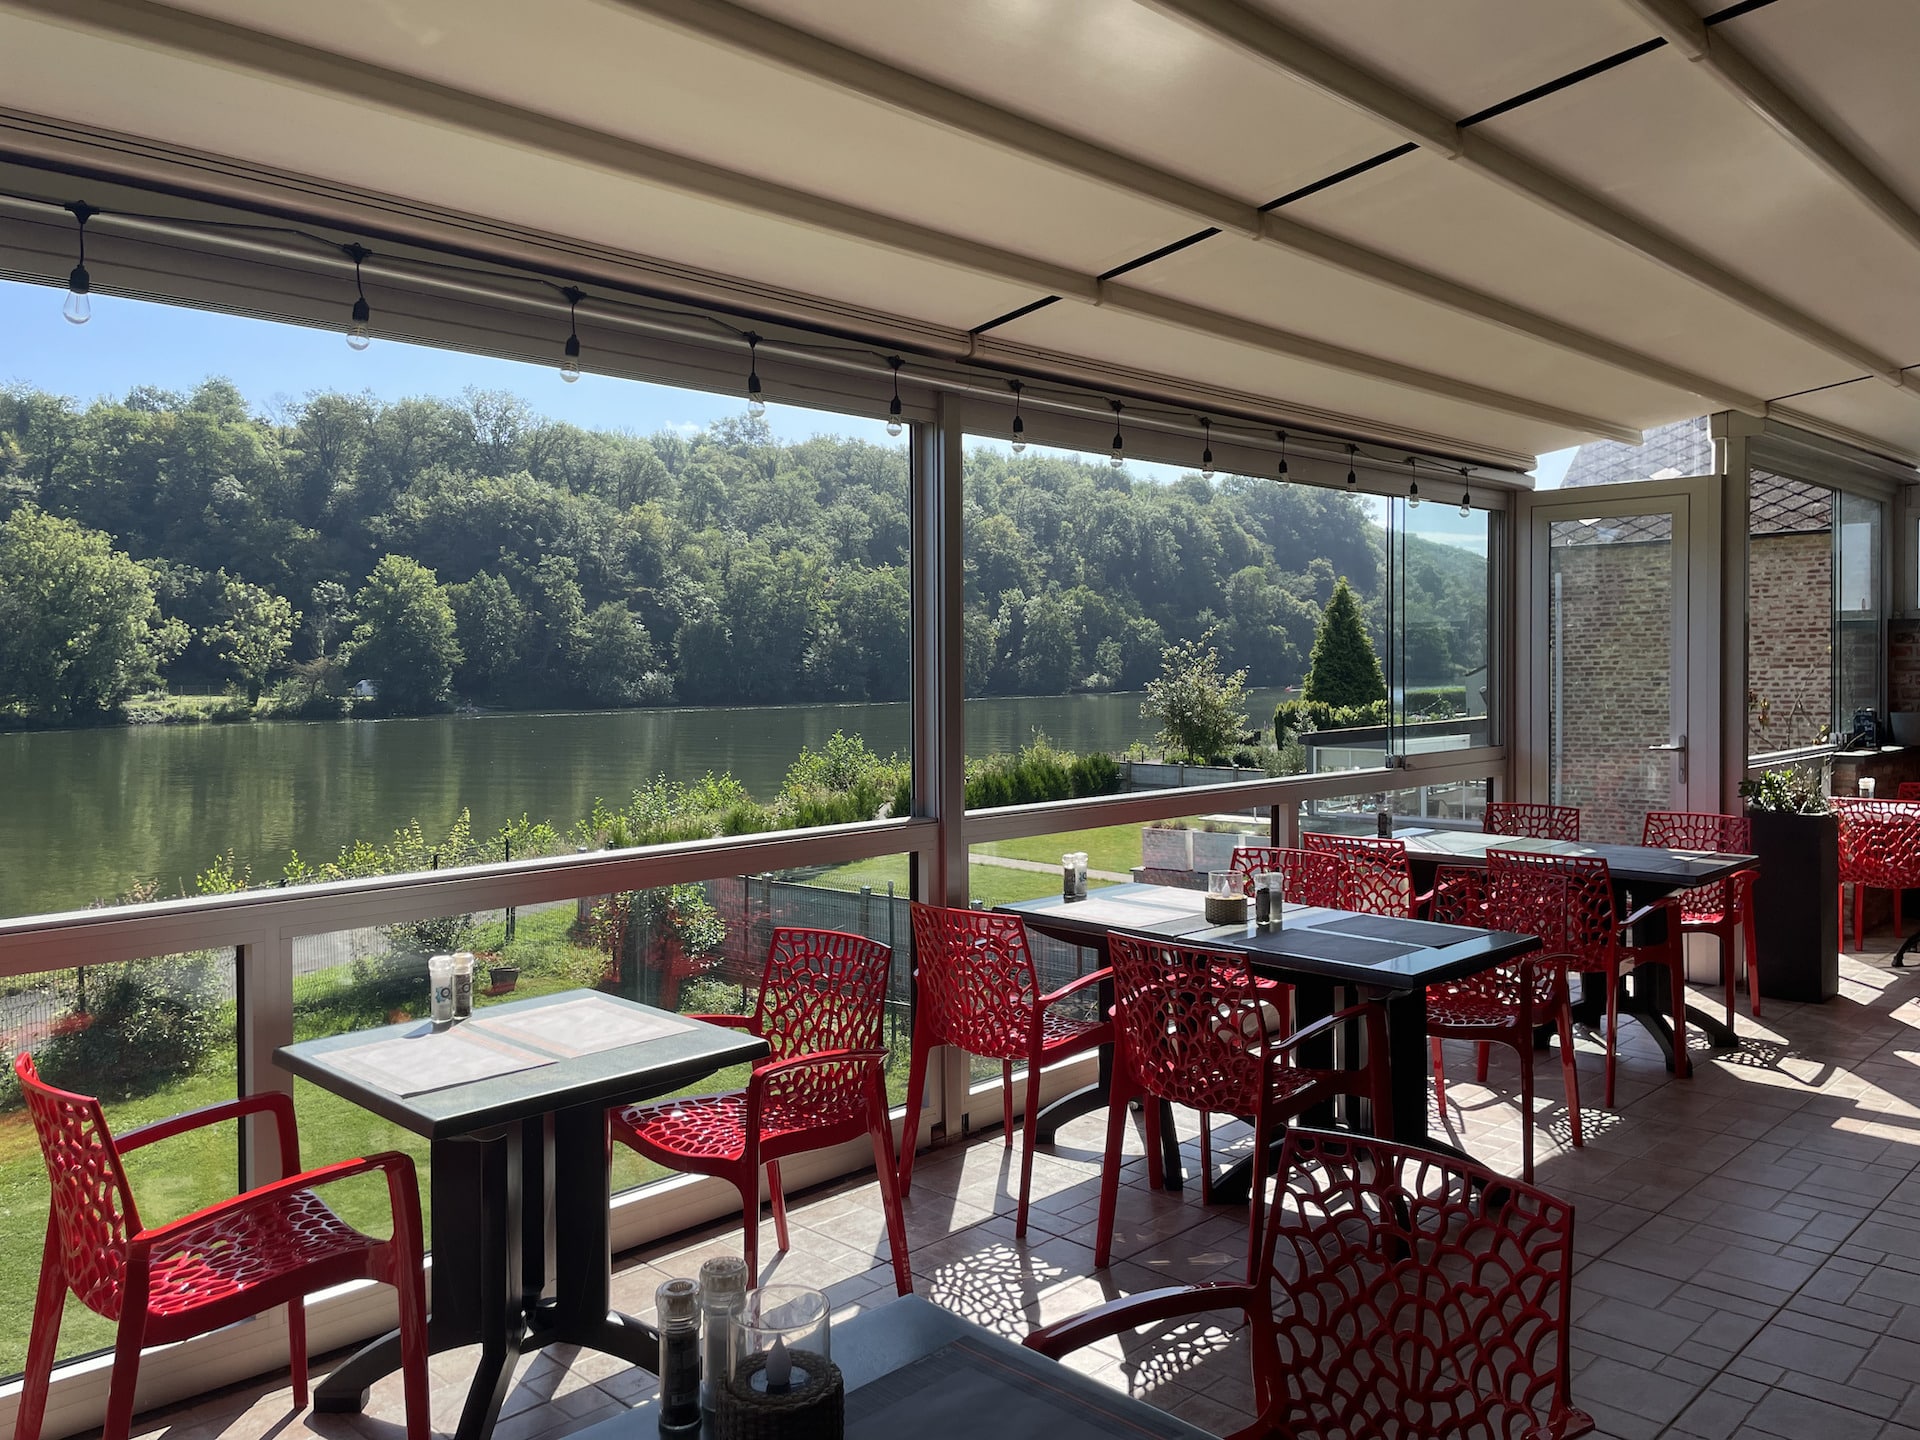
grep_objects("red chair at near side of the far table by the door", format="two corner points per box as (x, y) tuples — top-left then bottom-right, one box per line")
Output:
(1486, 849), (1692, 1110)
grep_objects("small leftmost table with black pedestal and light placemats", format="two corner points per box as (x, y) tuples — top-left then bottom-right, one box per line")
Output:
(275, 991), (768, 1440)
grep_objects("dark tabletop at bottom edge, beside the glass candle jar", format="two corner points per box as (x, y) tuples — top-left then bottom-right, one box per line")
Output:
(576, 1294), (1206, 1440)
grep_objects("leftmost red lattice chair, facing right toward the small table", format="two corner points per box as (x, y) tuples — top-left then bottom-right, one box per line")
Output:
(13, 1054), (432, 1440)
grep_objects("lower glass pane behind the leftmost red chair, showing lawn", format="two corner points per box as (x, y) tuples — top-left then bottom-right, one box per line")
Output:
(0, 950), (238, 1375)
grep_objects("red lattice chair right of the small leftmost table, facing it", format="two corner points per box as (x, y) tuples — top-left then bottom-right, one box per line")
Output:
(611, 927), (914, 1294)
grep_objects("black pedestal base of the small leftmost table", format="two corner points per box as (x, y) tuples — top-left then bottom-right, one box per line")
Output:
(313, 1106), (660, 1440)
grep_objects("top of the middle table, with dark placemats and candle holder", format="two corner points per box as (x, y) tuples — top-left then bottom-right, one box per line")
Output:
(998, 885), (1540, 991)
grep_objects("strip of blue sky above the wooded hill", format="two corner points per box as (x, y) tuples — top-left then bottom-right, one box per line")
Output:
(0, 280), (1572, 506)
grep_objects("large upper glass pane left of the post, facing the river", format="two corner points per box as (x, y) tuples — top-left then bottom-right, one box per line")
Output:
(0, 282), (912, 916)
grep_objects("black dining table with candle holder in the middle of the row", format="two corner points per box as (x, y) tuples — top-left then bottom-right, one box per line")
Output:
(1000, 883), (1540, 1204)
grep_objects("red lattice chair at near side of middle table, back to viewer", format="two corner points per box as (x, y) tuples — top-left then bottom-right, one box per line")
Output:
(1094, 935), (1392, 1277)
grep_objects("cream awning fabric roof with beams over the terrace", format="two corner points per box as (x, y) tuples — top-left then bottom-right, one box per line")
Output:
(0, 0), (1920, 468)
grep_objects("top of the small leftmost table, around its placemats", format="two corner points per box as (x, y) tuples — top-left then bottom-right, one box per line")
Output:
(273, 991), (768, 1140)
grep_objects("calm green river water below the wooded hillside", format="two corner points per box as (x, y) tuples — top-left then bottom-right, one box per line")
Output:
(0, 689), (1281, 916)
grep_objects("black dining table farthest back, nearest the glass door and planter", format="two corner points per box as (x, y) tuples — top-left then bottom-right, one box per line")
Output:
(1394, 828), (1759, 1069)
